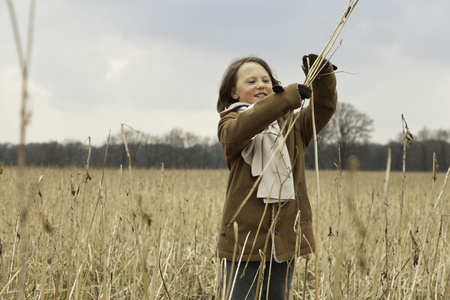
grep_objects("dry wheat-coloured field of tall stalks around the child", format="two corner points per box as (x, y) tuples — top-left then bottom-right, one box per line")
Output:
(0, 167), (450, 299)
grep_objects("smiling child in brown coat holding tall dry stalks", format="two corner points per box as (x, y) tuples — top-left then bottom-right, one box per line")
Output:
(217, 54), (337, 299)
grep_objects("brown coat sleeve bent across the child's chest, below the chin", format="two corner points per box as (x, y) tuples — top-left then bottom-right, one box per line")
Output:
(217, 84), (301, 161)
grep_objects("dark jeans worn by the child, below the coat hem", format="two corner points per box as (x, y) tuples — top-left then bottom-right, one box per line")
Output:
(222, 260), (294, 300)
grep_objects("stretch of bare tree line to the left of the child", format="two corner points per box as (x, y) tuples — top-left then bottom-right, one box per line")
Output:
(0, 128), (226, 169)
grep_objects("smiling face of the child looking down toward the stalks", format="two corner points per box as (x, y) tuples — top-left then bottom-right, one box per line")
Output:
(231, 62), (273, 104)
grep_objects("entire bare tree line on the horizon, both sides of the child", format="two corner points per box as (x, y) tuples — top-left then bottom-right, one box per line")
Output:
(0, 103), (450, 171)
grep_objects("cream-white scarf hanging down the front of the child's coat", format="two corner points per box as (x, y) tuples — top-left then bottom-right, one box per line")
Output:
(237, 105), (295, 203)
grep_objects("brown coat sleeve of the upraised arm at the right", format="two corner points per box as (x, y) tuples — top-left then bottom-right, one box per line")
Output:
(296, 67), (338, 150)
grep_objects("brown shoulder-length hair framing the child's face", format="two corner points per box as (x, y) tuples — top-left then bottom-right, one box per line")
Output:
(217, 56), (280, 113)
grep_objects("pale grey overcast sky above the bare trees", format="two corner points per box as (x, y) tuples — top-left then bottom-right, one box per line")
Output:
(0, 0), (450, 145)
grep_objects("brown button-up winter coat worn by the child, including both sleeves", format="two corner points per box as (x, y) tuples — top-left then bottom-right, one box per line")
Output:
(218, 64), (337, 261)
